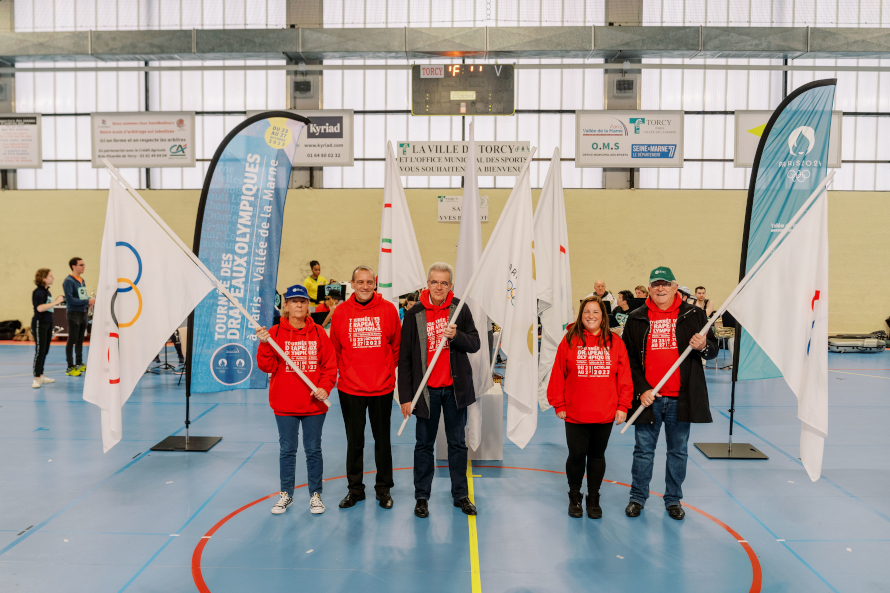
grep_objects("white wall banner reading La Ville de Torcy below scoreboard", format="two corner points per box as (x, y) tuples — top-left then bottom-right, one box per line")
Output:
(396, 141), (531, 177)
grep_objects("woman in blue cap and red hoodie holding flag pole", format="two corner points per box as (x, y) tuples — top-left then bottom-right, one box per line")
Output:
(256, 284), (337, 515)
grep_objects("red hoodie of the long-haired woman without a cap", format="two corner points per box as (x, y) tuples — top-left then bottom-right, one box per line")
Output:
(547, 326), (633, 424)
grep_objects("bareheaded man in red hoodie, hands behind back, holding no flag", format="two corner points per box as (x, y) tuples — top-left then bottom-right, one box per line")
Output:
(331, 266), (401, 509)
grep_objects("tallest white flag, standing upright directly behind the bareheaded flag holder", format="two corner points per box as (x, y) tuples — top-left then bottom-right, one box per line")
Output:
(454, 122), (494, 451)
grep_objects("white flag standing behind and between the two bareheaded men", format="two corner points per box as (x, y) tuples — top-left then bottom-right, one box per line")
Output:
(377, 142), (426, 307)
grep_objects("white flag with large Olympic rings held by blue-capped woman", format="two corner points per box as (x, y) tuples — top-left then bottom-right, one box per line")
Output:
(83, 177), (214, 452)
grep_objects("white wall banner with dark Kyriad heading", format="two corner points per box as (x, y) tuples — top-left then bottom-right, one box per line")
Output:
(247, 109), (355, 167)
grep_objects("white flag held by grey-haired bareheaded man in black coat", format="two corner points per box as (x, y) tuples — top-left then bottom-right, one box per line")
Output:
(461, 166), (538, 448)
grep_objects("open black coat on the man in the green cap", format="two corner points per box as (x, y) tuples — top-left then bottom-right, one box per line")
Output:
(621, 303), (717, 424)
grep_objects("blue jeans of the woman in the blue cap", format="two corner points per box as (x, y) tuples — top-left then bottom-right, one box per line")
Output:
(275, 414), (327, 496)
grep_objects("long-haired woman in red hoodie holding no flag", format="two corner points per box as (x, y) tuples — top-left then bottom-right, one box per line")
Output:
(547, 295), (633, 519)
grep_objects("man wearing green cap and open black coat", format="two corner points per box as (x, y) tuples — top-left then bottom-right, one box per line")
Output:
(621, 266), (717, 521)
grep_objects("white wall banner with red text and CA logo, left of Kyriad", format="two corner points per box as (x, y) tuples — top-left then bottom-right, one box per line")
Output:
(90, 111), (195, 169)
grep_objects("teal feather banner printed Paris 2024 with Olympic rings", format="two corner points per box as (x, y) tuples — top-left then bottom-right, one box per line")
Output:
(733, 78), (837, 380)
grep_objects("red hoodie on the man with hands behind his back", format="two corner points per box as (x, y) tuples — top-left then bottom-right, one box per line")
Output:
(331, 293), (402, 396)
